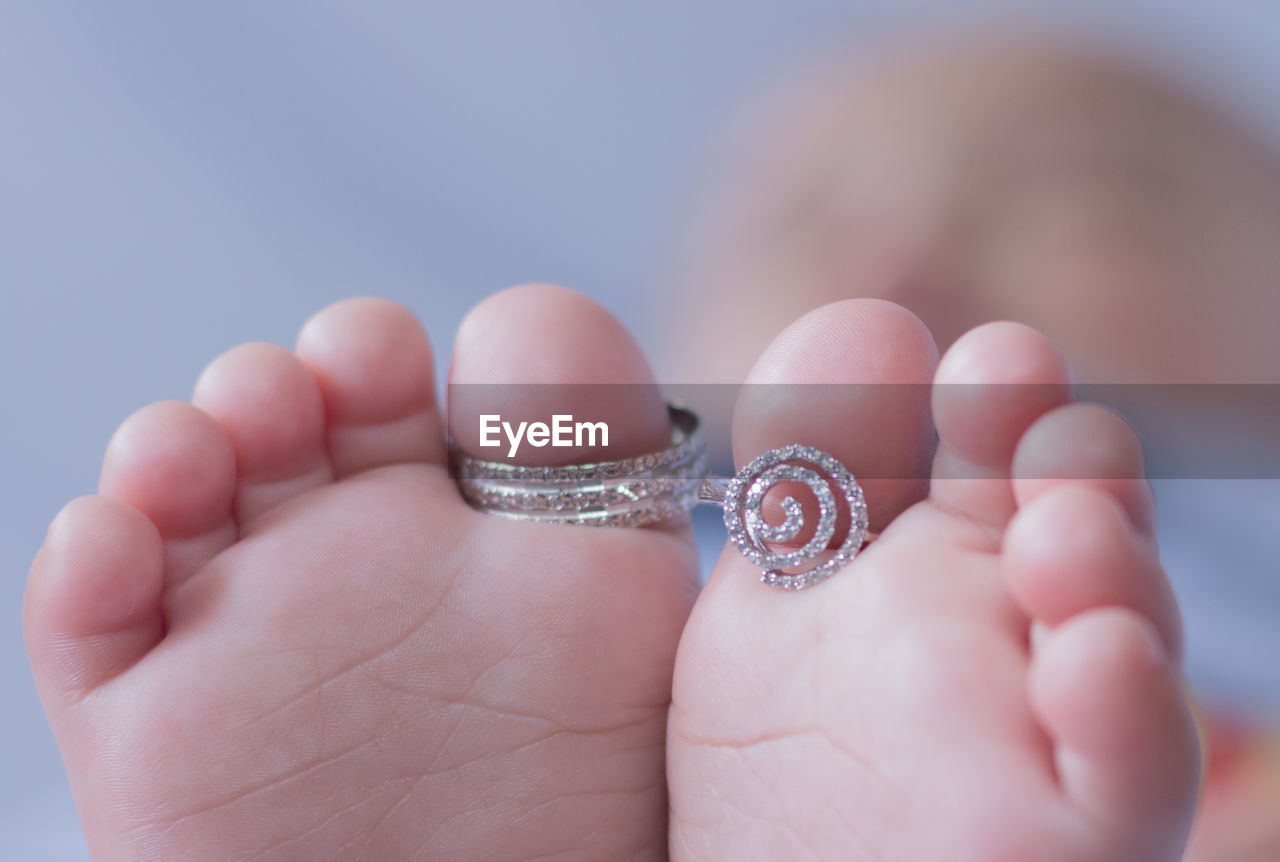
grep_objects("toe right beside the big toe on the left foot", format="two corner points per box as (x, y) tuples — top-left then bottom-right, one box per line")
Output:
(297, 298), (445, 478)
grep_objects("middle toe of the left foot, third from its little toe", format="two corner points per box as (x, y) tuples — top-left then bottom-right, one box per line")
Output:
(192, 343), (333, 532)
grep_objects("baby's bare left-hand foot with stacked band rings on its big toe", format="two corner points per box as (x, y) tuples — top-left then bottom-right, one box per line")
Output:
(26, 287), (696, 862)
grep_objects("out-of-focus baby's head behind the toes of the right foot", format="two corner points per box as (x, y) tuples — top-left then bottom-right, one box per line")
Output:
(668, 29), (1280, 383)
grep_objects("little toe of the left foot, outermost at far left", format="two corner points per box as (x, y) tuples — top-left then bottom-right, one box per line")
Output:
(23, 497), (164, 699)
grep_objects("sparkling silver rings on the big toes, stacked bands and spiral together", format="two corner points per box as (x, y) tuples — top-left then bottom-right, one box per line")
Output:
(449, 405), (874, 589)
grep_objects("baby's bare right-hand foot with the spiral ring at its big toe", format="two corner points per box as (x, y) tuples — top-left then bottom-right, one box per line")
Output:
(668, 300), (1198, 862)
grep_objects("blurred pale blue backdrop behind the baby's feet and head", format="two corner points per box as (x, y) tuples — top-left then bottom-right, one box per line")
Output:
(0, 0), (1280, 861)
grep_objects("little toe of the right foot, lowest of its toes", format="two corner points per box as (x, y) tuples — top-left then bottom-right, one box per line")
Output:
(1030, 608), (1199, 859)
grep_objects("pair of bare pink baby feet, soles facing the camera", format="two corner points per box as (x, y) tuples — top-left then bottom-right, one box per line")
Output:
(26, 286), (1199, 862)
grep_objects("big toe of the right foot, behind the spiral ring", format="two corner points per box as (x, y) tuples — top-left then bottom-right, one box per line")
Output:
(699, 294), (937, 612)
